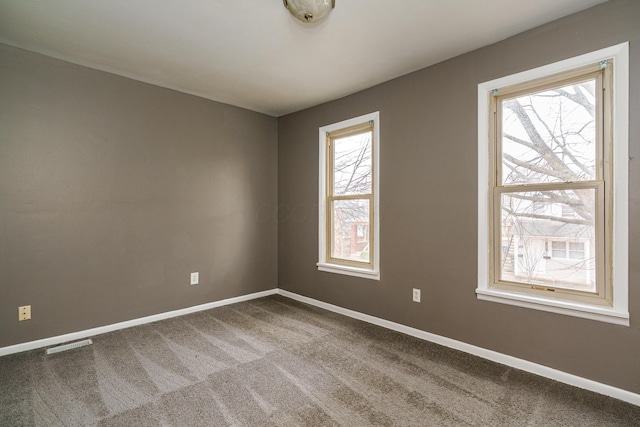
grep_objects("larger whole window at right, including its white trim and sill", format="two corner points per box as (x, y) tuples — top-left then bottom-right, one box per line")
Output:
(476, 44), (628, 325)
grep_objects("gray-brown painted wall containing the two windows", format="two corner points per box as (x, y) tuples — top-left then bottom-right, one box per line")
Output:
(278, 0), (640, 393)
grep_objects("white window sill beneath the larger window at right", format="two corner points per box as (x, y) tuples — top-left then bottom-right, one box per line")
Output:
(476, 288), (629, 326)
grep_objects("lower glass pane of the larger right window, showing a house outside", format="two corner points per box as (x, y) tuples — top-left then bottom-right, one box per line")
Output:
(500, 189), (596, 292)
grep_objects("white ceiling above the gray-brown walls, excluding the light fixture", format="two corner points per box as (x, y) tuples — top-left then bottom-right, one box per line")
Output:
(0, 0), (604, 116)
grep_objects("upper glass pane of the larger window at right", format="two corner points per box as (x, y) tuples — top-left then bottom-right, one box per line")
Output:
(501, 79), (596, 185)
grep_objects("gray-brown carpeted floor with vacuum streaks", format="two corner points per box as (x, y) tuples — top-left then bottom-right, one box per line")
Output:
(0, 296), (640, 427)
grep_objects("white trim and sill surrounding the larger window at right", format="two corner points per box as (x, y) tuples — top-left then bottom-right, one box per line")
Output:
(476, 42), (629, 326)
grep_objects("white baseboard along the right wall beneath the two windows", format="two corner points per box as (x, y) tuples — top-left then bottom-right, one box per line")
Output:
(277, 289), (640, 406)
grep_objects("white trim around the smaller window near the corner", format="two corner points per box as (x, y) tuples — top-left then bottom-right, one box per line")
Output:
(317, 111), (380, 280)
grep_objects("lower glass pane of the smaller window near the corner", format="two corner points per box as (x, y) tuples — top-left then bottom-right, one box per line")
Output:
(331, 199), (369, 263)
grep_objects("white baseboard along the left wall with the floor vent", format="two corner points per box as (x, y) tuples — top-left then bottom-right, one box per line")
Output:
(0, 289), (278, 356)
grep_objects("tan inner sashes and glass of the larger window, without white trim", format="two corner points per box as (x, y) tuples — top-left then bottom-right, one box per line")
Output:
(490, 61), (613, 306)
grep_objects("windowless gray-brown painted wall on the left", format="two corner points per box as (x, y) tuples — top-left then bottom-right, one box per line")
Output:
(0, 45), (277, 347)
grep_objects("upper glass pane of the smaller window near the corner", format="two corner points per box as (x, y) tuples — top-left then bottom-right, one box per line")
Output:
(333, 131), (372, 196)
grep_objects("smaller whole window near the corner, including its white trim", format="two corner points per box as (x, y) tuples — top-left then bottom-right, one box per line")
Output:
(318, 112), (380, 279)
